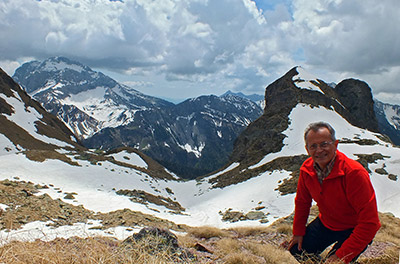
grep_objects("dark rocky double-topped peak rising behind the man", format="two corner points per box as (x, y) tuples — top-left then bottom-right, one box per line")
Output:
(231, 67), (378, 164)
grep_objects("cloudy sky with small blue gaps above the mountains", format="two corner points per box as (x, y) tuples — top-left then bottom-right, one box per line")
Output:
(0, 0), (400, 104)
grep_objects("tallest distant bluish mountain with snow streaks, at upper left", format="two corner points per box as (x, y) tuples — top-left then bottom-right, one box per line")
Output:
(13, 57), (173, 139)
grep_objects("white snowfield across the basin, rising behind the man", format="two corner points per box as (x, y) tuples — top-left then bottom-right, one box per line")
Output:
(0, 66), (400, 243)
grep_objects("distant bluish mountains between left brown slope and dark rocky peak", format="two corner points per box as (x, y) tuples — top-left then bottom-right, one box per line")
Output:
(13, 57), (262, 178)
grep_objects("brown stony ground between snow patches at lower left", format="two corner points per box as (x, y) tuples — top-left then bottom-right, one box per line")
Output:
(0, 180), (183, 231)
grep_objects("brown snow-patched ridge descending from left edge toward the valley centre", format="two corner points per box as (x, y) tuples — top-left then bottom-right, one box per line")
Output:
(0, 66), (176, 179)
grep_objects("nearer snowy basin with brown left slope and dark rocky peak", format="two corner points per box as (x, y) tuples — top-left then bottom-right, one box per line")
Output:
(0, 60), (400, 254)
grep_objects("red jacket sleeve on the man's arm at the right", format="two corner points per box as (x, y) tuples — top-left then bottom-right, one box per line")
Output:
(336, 168), (381, 263)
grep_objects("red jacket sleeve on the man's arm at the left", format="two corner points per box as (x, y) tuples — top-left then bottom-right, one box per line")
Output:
(293, 170), (312, 236)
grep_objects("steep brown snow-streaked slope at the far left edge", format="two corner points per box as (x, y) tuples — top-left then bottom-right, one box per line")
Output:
(0, 69), (79, 155)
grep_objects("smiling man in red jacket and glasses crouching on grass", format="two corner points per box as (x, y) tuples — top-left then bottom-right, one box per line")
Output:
(289, 122), (381, 263)
